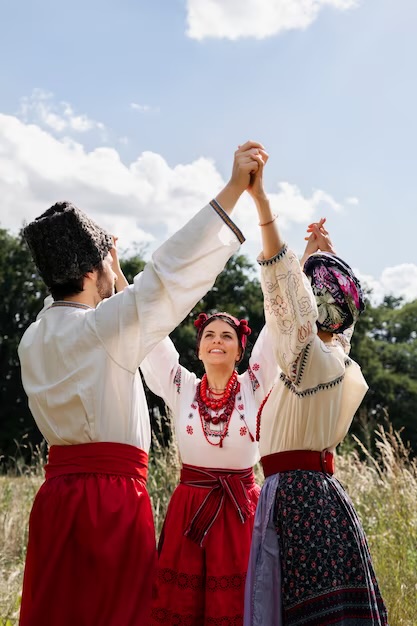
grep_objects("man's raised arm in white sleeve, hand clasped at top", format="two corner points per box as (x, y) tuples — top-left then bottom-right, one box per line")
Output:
(92, 142), (263, 372)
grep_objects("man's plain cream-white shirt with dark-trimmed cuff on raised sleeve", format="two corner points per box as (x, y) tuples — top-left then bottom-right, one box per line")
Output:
(19, 205), (243, 452)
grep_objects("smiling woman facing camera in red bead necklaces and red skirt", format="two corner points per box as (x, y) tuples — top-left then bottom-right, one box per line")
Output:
(141, 313), (276, 626)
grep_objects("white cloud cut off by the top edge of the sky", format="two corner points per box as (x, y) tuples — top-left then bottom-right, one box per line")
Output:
(187, 0), (359, 40)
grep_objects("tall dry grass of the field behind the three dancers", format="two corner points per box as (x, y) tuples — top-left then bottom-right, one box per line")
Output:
(0, 428), (417, 626)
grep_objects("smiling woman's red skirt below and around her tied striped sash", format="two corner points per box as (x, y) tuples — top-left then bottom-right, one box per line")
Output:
(151, 468), (260, 626)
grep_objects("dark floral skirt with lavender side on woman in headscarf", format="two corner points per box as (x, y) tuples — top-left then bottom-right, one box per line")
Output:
(245, 470), (388, 626)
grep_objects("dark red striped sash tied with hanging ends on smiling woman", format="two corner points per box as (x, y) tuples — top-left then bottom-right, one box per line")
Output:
(180, 465), (256, 546)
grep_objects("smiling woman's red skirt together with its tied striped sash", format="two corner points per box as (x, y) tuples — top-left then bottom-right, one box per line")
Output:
(151, 465), (260, 626)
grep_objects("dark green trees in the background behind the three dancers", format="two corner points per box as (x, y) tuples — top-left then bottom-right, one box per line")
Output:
(5, 224), (417, 456)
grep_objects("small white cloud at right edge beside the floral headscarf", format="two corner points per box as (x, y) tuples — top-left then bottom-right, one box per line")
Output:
(357, 263), (417, 304)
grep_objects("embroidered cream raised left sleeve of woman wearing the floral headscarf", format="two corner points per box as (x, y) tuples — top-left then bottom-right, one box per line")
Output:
(258, 245), (317, 383)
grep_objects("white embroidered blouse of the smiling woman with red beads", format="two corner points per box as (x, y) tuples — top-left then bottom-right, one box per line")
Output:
(141, 328), (276, 469)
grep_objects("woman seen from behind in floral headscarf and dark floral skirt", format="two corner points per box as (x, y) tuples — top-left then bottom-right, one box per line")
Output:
(240, 154), (387, 626)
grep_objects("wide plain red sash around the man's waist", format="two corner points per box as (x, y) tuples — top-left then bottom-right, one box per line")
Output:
(45, 441), (148, 482)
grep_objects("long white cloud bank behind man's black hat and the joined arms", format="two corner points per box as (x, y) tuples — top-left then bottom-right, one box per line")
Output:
(0, 109), (348, 258)
